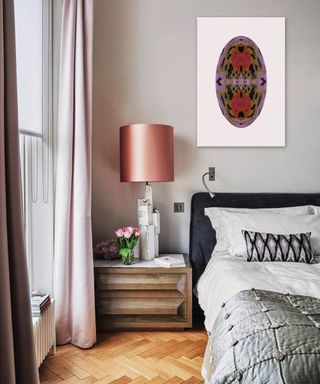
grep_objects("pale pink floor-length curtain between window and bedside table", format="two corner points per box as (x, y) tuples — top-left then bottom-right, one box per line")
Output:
(54, 0), (96, 348)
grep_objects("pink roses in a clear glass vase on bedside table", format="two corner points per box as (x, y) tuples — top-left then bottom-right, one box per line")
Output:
(115, 227), (141, 265)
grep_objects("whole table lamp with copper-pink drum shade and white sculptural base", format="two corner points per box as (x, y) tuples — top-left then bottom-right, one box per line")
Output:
(120, 124), (174, 260)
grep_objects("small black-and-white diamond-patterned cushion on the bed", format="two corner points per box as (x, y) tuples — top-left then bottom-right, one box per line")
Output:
(242, 230), (314, 263)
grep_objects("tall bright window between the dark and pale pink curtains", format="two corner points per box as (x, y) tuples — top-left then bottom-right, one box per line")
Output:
(15, 0), (53, 292)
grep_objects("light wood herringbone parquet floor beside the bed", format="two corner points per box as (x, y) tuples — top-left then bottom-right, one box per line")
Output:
(40, 330), (207, 384)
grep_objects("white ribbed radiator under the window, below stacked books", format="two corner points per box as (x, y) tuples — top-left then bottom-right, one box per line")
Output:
(32, 300), (56, 368)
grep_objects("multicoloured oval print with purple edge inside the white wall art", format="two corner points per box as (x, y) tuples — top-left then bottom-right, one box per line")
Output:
(216, 36), (267, 128)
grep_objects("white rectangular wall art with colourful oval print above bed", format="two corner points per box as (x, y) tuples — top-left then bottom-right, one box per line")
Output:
(197, 17), (285, 147)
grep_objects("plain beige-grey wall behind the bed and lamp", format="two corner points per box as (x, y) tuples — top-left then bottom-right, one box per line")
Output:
(93, 0), (320, 252)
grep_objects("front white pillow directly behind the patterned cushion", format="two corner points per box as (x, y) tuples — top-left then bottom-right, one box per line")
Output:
(224, 212), (320, 256)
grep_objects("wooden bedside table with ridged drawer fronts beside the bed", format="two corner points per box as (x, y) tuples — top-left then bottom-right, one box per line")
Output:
(94, 255), (192, 330)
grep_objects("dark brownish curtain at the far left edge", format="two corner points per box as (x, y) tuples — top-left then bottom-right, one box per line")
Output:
(0, 0), (38, 384)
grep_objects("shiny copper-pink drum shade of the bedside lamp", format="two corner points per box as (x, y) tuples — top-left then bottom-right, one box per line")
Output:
(120, 124), (174, 182)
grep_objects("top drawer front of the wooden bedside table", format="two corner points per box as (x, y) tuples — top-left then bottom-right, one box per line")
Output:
(95, 273), (187, 292)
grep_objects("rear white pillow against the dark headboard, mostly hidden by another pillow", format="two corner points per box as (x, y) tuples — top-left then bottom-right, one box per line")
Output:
(204, 205), (320, 253)
